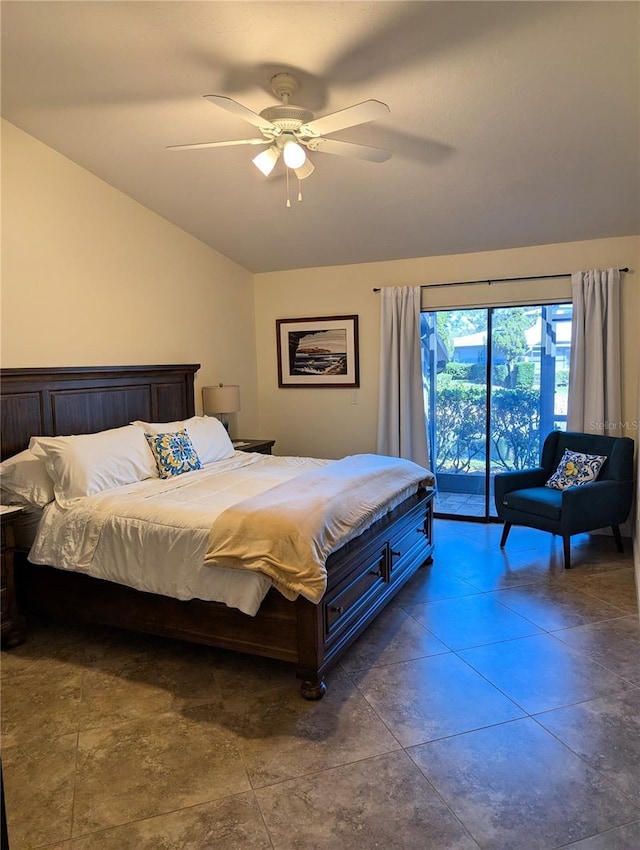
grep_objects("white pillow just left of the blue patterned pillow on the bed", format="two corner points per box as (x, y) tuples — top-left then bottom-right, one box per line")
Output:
(29, 425), (158, 505)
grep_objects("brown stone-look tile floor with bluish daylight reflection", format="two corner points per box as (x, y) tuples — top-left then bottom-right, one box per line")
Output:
(2, 520), (640, 850)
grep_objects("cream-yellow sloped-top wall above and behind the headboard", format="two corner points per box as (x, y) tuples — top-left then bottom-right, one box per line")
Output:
(1, 122), (259, 435)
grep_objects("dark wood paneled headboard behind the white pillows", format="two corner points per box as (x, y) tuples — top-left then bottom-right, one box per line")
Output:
(0, 364), (200, 458)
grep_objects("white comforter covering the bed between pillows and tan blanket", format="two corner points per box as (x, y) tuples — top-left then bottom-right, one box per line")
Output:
(29, 452), (436, 615)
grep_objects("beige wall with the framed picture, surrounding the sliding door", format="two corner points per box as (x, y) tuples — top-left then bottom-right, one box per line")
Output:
(255, 237), (640, 457)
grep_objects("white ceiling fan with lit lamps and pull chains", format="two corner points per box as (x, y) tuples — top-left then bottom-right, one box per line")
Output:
(167, 73), (392, 199)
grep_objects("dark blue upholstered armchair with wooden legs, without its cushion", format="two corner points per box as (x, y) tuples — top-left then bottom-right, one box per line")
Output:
(494, 431), (634, 569)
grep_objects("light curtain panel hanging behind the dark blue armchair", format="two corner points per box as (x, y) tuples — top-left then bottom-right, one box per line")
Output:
(567, 269), (622, 437)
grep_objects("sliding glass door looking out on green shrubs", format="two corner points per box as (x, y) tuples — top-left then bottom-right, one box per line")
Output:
(422, 304), (571, 520)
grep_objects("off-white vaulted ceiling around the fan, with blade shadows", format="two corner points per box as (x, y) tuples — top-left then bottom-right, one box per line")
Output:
(2, 0), (640, 272)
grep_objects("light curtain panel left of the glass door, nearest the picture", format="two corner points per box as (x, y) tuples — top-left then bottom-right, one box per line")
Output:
(377, 286), (429, 468)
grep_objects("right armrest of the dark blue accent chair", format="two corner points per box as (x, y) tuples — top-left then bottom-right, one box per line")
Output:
(562, 481), (633, 529)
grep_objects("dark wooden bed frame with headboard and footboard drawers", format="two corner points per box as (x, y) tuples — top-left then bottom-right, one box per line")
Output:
(0, 365), (433, 699)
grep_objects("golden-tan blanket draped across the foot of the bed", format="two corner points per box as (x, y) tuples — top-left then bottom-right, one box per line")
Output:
(205, 454), (434, 603)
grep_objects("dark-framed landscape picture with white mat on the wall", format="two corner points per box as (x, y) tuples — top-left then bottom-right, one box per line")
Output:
(276, 316), (360, 387)
